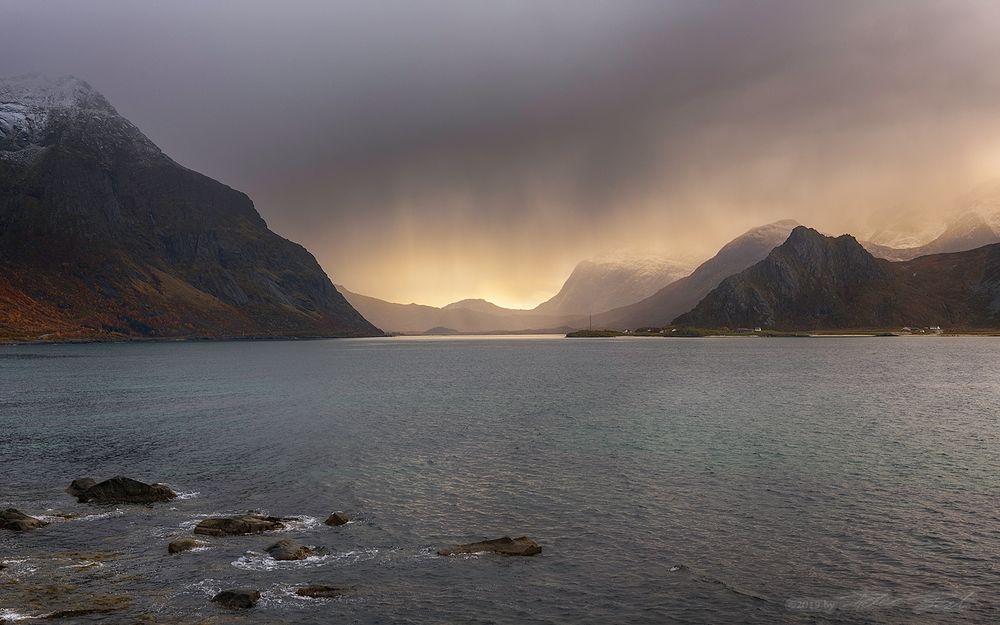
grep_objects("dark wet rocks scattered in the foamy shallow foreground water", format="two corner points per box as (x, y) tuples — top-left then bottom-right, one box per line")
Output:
(0, 476), (542, 625)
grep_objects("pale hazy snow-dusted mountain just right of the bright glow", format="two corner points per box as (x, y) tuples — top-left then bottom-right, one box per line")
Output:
(534, 256), (691, 315)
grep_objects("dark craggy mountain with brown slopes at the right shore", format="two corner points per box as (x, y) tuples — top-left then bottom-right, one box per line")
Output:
(674, 227), (1000, 329)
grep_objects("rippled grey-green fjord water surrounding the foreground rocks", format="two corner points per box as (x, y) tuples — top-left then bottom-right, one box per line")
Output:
(0, 337), (1000, 624)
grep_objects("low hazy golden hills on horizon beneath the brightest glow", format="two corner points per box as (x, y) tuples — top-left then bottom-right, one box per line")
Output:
(337, 286), (586, 334)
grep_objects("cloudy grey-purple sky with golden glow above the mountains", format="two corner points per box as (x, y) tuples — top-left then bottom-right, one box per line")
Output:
(0, 0), (1000, 307)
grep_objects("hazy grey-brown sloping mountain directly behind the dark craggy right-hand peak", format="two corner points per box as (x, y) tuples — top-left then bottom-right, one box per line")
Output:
(593, 219), (799, 329)
